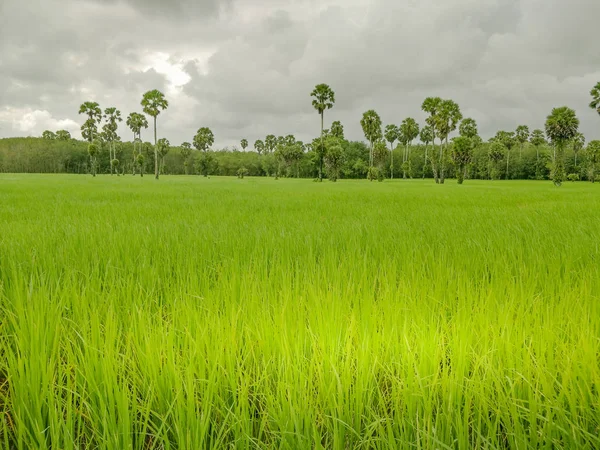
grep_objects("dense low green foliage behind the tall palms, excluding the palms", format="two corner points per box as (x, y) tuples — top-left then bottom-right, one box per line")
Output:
(0, 138), (600, 180)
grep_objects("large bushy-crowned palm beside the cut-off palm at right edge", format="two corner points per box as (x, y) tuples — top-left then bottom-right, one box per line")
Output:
(546, 106), (579, 186)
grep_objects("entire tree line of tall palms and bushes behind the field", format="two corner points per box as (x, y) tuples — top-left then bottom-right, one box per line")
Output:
(0, 83), (600, 185)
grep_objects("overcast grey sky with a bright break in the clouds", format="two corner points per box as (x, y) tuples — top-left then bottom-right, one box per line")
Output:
(0, 0), (600, 148)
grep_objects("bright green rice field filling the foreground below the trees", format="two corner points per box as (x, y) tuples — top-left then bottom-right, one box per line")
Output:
(0, 175), (600, 450)
